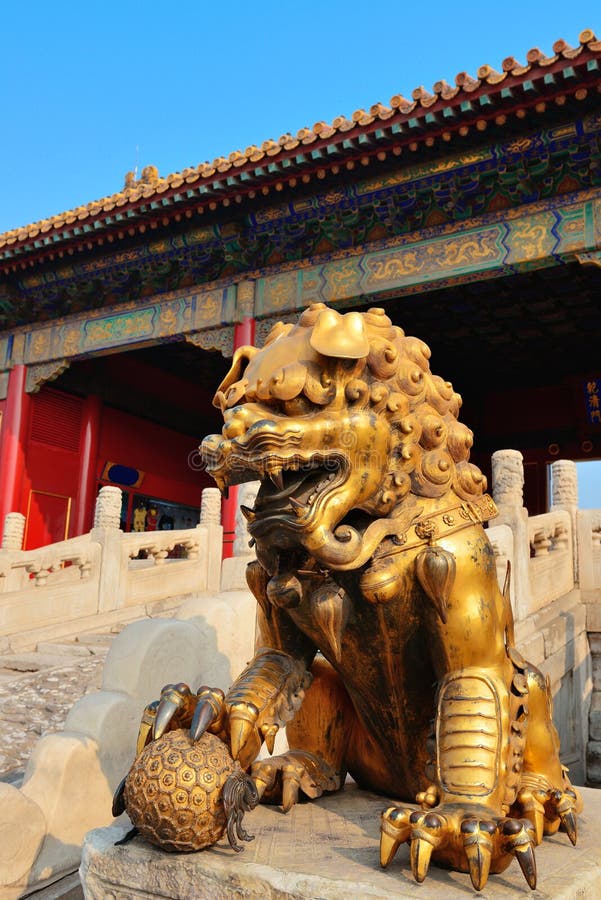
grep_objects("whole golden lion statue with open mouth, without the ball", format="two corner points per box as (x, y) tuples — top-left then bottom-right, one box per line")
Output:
(126, 304), (581, 890)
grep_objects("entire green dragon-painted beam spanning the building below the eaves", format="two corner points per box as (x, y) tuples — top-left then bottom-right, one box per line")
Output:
(0, 188), (601, 380)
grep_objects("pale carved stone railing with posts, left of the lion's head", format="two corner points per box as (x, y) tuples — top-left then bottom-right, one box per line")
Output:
(0, 487), (222, 650)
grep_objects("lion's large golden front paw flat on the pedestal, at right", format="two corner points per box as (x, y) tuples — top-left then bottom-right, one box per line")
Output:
(380, 805), (536, 891)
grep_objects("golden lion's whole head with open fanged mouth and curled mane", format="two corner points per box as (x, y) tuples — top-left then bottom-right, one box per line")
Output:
(202, 303), (486, 570)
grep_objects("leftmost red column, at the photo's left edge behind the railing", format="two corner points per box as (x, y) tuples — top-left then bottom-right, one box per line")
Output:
(0, 365), (31, 535)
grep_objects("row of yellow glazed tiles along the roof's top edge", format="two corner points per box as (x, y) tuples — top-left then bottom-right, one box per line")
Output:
(0, 30), (601, 259)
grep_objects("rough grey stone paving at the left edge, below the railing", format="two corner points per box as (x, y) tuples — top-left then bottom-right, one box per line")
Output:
(0, 653), (106, 780)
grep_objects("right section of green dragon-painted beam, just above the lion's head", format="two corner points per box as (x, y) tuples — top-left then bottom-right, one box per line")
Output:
(255, 191), (601, 316)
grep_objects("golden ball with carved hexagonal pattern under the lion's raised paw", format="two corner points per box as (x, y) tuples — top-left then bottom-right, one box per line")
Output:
(125, 729), (240, 852)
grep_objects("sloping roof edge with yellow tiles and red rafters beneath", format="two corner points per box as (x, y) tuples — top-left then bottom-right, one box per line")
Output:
(0, 30), (601, 271)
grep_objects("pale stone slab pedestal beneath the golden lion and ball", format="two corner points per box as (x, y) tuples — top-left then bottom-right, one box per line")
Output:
(80, 785), (601, 900)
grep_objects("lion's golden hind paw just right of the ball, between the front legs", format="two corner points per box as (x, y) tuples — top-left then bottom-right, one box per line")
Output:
(251, 750), (340, 812)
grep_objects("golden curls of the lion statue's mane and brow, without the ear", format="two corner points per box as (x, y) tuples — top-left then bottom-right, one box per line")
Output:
(268, 304), (486, 509)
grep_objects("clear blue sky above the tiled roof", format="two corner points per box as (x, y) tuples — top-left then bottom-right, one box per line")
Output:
(0, 0), (601, 232)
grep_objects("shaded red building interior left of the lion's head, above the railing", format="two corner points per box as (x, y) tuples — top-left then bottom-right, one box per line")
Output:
(16, 341), (228, 547)
